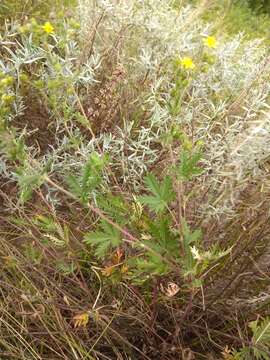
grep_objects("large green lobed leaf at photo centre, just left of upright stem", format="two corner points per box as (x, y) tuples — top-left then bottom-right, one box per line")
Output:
(139, 174), (175, 213)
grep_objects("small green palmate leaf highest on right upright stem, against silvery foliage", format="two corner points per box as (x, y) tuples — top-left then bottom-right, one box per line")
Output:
(178, 150), (203, 180)
